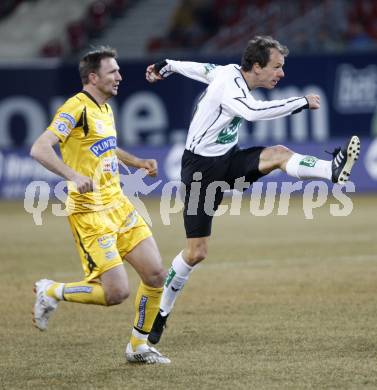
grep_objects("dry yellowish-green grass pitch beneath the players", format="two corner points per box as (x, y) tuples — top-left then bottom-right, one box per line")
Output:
(0, 196), (377, 390)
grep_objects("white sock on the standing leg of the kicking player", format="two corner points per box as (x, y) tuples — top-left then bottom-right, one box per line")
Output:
(160, 252), (193, 316)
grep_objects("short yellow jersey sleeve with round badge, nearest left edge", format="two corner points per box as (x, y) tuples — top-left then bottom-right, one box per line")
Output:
(47, 97), (84, 143)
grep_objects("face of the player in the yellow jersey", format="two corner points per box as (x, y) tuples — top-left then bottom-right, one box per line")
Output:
(96, 58), (122, 98)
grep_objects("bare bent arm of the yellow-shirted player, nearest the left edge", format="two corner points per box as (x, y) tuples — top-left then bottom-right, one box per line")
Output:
(30, 130), (93, 194)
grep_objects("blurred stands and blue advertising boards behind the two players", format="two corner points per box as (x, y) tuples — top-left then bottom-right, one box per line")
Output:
(0, 0), (377, 195)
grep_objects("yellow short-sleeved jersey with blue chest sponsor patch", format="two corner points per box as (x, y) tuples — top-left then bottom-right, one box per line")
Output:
(47, 91), (124, 213)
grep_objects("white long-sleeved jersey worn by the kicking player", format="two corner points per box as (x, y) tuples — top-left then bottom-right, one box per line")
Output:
(164, 60), (308, 156)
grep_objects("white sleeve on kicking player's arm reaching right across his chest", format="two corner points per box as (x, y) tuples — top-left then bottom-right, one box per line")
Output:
(222, 79), (309, 121)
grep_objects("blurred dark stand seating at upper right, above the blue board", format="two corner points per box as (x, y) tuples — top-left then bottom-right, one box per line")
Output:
(149, 0), (377, 53)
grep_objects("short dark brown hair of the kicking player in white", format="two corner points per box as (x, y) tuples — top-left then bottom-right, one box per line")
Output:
(241, 35), (289, 72)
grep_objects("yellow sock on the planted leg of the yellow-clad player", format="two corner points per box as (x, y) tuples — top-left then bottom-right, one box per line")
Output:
(131, 282), (163, 351)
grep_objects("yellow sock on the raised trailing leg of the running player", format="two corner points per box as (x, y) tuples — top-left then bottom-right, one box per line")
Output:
(47, 282), (107, 306)
